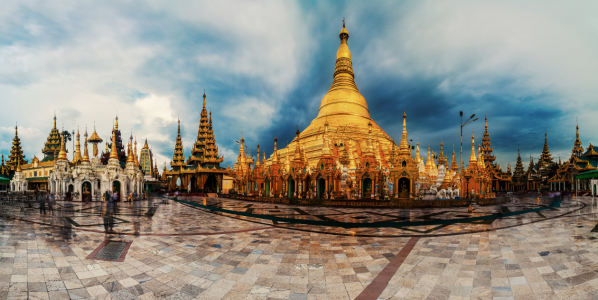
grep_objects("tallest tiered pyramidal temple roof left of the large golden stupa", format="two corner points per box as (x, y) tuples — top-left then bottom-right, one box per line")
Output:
(187, 92), (224, 167)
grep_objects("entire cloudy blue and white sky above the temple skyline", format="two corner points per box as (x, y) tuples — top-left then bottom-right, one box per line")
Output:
(0, 1), (598, 169)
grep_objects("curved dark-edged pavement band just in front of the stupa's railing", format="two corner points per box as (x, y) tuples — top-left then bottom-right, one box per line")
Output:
(179, 197), (587, 237)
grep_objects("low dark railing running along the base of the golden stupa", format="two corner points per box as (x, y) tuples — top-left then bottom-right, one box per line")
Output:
(210, 194), (510, 208)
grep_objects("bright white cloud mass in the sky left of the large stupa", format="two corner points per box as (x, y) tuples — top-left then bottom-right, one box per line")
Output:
(0, 1), (310, 164)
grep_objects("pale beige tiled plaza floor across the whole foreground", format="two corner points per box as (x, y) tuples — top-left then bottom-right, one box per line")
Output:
(0, 198), (598, 299)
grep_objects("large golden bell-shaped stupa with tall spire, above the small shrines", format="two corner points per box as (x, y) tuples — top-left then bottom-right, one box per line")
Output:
(266, 21), (394, 168)
